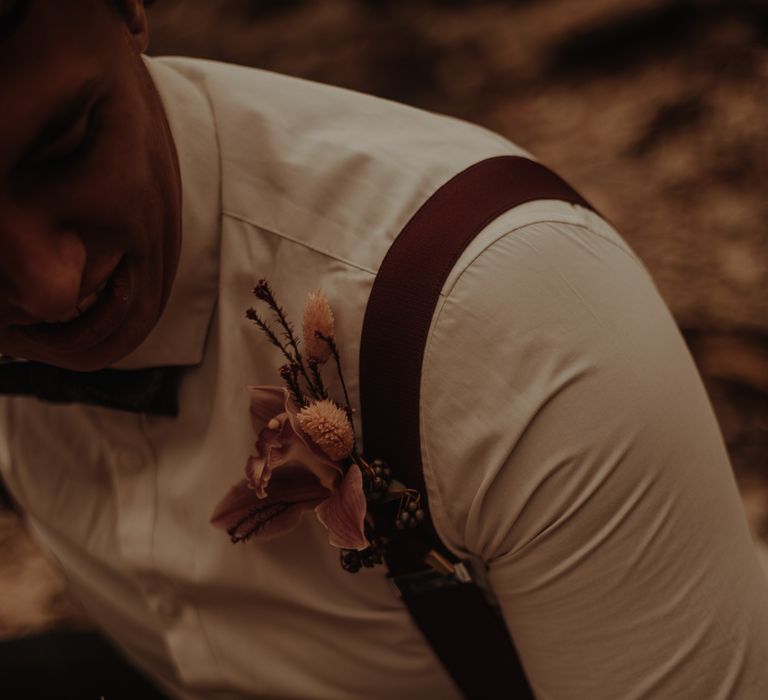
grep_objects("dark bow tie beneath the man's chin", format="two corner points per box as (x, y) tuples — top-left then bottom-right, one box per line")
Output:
(0, 360), (184, 416)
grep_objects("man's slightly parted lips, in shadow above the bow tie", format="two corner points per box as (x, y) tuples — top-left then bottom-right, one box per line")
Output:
(16, 258), (135, 354)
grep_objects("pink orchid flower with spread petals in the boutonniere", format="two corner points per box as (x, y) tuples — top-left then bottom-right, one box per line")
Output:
(211, 386), (369, 550)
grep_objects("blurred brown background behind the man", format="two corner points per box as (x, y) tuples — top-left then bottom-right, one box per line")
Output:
(0, 0), (768, 636)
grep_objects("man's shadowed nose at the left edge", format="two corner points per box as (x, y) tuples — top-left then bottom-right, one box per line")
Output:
(0, 201), (86, 323)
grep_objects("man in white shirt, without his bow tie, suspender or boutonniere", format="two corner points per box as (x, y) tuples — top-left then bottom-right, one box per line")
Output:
(0, 0), (768, 699)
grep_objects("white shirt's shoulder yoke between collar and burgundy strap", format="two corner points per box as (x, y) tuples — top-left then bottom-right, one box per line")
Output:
(148, 58), (524, 271)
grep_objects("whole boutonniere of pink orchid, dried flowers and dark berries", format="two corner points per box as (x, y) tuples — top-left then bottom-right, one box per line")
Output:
(211, 280), (424, 572)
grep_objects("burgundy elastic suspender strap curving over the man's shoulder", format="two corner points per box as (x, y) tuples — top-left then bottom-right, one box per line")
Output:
(360, 156), (591, 700)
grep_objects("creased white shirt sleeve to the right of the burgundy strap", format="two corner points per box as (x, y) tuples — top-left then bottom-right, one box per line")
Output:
(421, 209), (768, 700)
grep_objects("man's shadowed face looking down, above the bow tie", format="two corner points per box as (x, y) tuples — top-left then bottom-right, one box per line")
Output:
(0, 0), (181, 370)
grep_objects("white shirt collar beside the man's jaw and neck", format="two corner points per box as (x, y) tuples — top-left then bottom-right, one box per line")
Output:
(114, 58), (221, 369)
